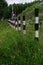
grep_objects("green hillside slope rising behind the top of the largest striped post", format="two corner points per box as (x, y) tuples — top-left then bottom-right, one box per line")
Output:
(18, 2), (43, 21)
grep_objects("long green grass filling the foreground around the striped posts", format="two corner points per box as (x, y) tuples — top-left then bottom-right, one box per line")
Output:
(0, 2), (43, 65)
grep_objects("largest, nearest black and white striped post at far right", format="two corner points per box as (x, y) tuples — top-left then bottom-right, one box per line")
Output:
(35, 8), (39, 40)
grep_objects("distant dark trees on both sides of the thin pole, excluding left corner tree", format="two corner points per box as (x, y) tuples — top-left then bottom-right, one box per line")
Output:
(8, 3), (31, 16)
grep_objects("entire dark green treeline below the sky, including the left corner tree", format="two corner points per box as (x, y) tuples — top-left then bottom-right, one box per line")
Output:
(0, 0), (31, 19)
